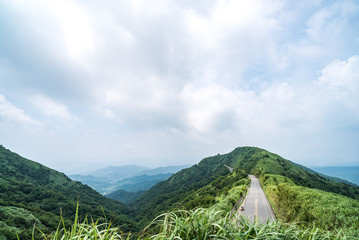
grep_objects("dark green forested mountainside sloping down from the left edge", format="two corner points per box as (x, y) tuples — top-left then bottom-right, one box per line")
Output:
(0, 145), (137, 239)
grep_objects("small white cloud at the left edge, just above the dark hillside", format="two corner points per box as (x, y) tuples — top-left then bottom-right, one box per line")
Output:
(0, 94), (41, 125)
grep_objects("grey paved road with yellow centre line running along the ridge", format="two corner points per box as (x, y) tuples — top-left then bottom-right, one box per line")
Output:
(241, 175), (274, 223)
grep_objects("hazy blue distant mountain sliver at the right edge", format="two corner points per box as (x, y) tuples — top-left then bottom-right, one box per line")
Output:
(312, 166), (359, 185)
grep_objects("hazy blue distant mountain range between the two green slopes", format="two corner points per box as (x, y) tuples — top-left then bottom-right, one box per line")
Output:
(69, 165), (190, 195)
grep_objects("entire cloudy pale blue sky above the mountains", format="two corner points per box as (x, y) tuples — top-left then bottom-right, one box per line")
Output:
(0, 0), (359, 173)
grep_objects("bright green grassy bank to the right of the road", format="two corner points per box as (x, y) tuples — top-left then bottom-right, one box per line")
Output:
(261, 175), (359, 230)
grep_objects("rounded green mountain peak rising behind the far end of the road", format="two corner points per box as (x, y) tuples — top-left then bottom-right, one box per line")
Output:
(130, 147), (359, 226)
